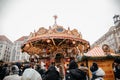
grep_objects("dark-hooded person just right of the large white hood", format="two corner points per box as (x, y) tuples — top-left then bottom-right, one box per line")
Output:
(43, 65), (61, 80)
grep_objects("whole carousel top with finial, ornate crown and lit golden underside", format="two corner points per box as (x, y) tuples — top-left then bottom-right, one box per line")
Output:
(21, 16), (90, 57)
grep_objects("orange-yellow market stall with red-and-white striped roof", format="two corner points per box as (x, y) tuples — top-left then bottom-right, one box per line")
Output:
(84, 46), (120, 80)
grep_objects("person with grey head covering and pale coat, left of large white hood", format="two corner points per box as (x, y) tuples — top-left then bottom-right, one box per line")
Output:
(3, 65), (21, 80)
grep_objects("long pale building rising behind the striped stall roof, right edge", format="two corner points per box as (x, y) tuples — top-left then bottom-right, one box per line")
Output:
(92, 15), (120, 53)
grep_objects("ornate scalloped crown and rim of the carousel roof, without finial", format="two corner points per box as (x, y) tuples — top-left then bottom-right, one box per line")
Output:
(27, 25), (87, 43)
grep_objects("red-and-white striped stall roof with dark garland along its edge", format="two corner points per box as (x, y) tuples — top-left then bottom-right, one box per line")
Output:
(82, 46), (120, 60)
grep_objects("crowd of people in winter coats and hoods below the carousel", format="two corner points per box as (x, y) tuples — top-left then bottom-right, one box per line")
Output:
(0, 57), (120, 80)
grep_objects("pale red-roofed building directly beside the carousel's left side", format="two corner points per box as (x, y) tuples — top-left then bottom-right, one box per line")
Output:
(11, 36), (29, 61)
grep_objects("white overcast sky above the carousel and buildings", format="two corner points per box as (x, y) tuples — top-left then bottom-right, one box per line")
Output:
(0, 0), (120, 44)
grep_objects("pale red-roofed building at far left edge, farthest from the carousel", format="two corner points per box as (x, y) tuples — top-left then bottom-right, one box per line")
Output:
(0, 35), (13, 62)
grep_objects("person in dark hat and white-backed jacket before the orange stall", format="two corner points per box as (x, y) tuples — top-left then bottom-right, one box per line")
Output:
(90, 63), (105, 80)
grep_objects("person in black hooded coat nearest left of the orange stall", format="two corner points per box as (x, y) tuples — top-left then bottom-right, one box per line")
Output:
(65, 60), (86, 80)
